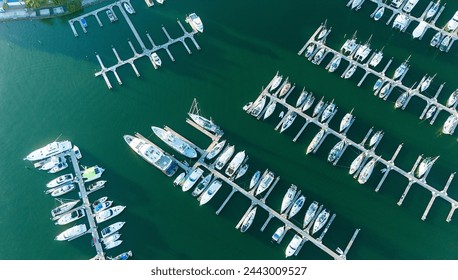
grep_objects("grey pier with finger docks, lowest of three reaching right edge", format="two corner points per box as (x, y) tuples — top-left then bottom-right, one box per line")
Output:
(245, 72), (458, 222)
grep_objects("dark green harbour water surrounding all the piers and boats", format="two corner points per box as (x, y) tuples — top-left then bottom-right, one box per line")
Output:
(0, 0), (458, 260)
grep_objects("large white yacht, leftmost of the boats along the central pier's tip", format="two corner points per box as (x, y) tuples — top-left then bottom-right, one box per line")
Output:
(124, 135), (178, 177)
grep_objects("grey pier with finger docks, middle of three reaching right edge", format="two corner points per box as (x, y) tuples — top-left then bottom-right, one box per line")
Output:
(298, 25), (458, 134)
